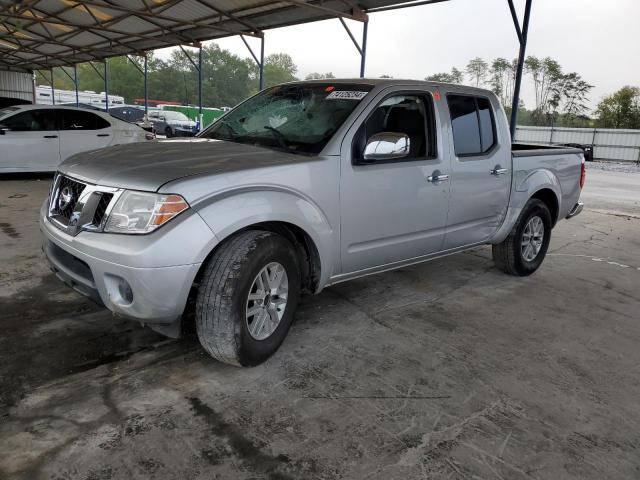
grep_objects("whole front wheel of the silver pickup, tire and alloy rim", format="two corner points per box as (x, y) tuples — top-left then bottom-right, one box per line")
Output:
(196, 230), (300, 366)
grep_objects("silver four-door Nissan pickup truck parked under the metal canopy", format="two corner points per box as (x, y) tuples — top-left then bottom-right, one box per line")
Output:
(40, 80), (585, 365)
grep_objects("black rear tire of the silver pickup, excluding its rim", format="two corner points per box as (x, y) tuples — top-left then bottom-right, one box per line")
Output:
(492, 198), (552, 277)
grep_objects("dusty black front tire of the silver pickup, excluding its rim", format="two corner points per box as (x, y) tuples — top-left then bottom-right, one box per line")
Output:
(196, 230), (300, 366)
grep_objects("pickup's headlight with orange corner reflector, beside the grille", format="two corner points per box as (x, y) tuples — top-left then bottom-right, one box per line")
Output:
(104, 190), (189, 233)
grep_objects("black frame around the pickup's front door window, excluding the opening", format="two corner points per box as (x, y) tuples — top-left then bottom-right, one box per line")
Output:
(351, 90), (438, 167)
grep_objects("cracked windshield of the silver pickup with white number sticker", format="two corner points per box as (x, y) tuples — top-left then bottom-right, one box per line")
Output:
(200, 84), (372, 154)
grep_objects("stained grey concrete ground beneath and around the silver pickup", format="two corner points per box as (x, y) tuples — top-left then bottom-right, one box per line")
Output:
(0, 165), (640, 480)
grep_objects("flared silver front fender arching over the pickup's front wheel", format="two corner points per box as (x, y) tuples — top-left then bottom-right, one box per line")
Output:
(192, 185), (338, 287)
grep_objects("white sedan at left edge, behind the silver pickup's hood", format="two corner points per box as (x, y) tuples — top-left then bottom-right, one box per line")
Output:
(0, 105), (153, 173)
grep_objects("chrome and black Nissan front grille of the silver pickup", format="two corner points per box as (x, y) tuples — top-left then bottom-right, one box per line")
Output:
(48, 174), (121, 235)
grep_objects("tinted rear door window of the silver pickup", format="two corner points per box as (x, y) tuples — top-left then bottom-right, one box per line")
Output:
(447, 95), (496, 157)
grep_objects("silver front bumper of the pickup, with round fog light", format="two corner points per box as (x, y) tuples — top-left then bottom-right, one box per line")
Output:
(40, 199), (215, 325)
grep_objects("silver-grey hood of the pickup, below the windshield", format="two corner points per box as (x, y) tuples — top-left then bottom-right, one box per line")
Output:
(58, 138), (311, 191)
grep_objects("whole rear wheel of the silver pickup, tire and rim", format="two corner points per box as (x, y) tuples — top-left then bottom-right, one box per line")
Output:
(492, 199), (552, 277)
